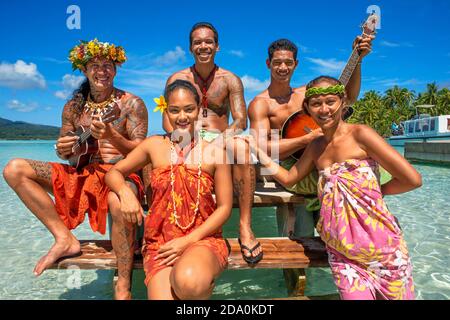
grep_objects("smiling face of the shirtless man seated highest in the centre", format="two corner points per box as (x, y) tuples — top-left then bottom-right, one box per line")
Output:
(190, 27), (219, 63)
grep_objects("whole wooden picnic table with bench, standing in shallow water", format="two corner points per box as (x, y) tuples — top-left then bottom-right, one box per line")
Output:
(51, 183), (329, 297)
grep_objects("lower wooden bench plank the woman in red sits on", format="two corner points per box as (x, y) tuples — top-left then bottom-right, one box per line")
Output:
(51, 238), (328, 270)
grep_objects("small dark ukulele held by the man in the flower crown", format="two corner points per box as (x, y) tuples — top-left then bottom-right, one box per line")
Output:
(67, 103), (127, 170)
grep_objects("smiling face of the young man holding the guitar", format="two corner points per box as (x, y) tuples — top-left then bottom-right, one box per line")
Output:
(266, 50), (298, 82)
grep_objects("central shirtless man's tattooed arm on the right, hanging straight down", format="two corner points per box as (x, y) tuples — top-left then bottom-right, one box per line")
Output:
(228, 73), (247, 130)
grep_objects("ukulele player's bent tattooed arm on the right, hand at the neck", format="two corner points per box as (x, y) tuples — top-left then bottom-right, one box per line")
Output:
(93, 96), (148, 155)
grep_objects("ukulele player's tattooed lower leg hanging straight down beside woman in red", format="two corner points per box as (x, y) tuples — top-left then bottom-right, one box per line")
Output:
(108, 182), (137, 300)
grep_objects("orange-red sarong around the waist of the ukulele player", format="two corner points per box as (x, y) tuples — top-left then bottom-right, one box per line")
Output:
(50, 162), (144, 234)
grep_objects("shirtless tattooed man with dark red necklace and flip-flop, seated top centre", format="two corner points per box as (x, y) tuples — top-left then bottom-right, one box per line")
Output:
(163, 22), (262, 263)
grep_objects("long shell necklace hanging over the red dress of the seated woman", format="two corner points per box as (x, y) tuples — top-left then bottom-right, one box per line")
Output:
(170, 138), (202, 231)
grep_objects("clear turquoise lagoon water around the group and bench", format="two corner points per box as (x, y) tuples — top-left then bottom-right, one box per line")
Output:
(0, 141), (450, 300)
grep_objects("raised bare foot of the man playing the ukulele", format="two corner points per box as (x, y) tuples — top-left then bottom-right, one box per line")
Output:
(33, 237), (81, 277)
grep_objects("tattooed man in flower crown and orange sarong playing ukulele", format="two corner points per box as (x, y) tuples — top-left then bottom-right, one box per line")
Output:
(3, 39), (148, 299)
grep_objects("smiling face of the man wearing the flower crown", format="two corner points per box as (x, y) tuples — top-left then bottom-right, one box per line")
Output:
(82, 57), (116, 91)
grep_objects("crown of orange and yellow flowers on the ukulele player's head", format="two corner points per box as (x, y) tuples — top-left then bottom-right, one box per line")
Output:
(69, 39), (127, 70)
